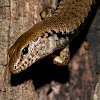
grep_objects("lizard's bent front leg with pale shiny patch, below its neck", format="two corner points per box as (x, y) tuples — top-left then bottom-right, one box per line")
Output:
(53, 45), (70, 66)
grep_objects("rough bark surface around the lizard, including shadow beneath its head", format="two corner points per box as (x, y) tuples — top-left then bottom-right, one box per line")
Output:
(0, 0), (100, 100)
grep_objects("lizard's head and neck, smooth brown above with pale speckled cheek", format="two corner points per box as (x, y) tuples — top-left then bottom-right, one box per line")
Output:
(8, 21), (63, 74)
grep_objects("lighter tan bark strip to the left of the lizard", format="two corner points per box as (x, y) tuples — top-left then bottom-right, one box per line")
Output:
(0, 0), (42, 100)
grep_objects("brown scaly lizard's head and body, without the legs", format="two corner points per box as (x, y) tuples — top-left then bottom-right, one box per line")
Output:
(8, 0), (94, 73)
